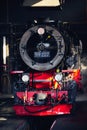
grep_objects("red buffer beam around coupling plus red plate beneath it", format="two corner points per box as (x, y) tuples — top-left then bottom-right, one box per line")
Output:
(14, 90), (72, 116)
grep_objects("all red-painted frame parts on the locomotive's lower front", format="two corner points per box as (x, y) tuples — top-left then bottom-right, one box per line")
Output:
(11, 69), (81, 116)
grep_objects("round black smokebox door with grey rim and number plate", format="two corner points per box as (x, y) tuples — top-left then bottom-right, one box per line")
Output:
(19, 24), (65, 71)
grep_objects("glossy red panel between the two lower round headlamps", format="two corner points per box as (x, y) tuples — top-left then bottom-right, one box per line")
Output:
(30, 70), (54, 89)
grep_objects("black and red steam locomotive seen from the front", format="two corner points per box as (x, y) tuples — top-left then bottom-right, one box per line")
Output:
(11, 20), (82, 116)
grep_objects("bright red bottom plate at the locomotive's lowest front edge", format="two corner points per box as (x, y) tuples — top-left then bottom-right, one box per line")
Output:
(14, 104), (72, 116)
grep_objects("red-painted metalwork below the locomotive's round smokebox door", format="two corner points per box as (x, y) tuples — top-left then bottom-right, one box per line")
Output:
(12, 69), (81, 116)
